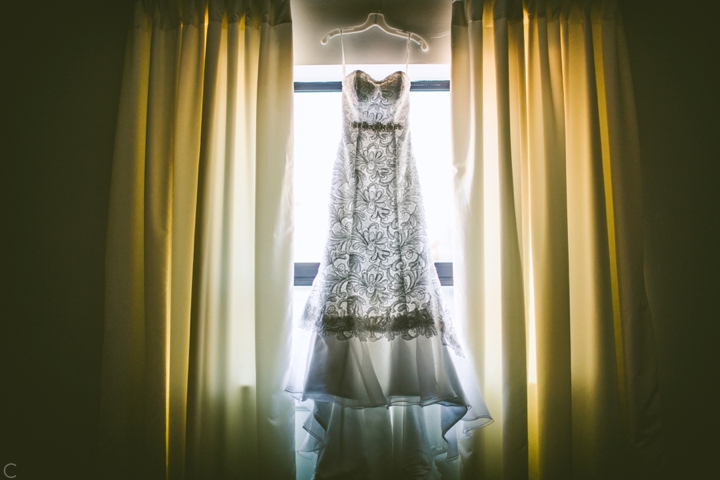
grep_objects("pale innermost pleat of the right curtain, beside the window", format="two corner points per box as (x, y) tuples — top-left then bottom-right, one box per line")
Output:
(451, 4), (492, 478)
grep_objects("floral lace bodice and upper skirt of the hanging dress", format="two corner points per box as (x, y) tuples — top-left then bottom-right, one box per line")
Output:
(302, 71), (462, 355)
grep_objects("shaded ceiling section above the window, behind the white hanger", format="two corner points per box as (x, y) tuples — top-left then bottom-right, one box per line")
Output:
(291, 0), (452, 65)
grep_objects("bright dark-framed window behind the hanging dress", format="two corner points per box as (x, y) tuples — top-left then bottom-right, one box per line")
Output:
(294, 65), (453, 286)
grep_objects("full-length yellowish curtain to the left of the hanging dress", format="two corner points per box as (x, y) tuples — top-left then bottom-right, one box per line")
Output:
(98, 0), (295, 479)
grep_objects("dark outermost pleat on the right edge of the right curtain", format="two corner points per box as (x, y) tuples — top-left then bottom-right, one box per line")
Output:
(593, 12), (661, 447)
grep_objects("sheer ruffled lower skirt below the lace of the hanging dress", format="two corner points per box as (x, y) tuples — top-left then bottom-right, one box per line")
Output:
(286, 324), (492, 480)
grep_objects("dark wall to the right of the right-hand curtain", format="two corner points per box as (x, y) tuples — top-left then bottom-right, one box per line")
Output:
(623, 0), (720, 479)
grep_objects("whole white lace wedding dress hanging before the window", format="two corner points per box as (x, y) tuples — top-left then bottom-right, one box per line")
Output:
(286, 71), (492, 480)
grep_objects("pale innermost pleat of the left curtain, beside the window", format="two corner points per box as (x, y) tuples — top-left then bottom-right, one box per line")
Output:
(255, 12), (295, 478)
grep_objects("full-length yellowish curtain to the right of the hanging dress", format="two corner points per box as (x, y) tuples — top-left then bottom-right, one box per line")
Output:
(451, 0), (660, 479)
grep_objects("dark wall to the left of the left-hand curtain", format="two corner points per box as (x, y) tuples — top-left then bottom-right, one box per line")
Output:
(0, 0), (132, 480)
